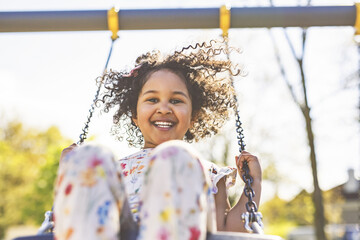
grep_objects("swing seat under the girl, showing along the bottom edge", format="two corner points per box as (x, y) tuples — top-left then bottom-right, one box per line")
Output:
(13, 232), (282, 240)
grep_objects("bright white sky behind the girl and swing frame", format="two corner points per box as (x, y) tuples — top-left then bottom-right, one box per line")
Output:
(0, 0), (360, 202)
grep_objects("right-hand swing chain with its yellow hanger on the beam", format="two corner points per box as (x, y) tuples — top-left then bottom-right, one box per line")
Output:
(220, 6), (263, 234)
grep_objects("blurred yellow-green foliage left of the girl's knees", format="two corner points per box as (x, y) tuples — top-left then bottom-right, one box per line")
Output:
(0, 122), (70, 239)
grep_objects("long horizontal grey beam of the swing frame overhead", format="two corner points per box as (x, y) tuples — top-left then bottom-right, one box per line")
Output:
(0, 5), (356, 32)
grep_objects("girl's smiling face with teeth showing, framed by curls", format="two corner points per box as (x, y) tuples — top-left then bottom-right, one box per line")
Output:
(133, 69), (192, 148)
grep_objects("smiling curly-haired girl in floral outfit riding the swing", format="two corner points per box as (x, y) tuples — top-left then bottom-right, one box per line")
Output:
(54, 42), (261, 240)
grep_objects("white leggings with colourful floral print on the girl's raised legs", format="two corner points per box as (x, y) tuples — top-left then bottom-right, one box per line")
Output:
(54, 141), (215, 240)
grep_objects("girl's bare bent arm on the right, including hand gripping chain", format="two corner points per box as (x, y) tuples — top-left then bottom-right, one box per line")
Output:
(215, 151), (262, 232)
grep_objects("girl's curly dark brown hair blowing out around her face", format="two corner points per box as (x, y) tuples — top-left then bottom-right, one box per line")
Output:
(97, 40), (241, 147)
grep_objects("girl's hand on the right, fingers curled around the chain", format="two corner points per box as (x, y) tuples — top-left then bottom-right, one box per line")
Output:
(235, 151), (262, 181)
